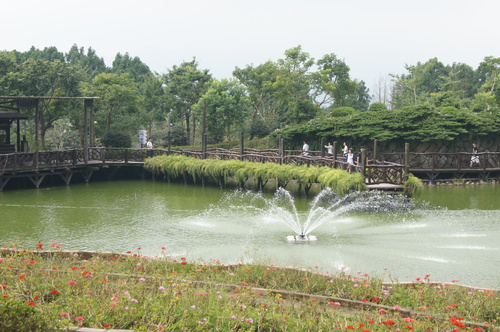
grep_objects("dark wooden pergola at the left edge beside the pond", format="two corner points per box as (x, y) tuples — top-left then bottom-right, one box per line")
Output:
(0, 96), (99, 157)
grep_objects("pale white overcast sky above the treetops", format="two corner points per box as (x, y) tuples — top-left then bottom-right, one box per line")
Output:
(0, 0), (500, 90)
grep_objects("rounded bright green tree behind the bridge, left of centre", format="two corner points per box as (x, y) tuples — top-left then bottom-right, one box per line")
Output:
(194, 79), (251, 143)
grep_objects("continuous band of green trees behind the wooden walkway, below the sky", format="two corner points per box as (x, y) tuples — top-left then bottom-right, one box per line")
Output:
(0, 44), (500, 152)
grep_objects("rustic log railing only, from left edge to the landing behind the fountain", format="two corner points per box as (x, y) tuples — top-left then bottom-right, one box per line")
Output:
(0, 147), (405, 184)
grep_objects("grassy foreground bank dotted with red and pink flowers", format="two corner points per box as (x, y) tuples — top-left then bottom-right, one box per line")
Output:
(0, 242), (500, 332)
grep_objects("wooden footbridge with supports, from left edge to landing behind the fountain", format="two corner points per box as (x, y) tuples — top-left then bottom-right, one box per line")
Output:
(0, 147), (405, 191)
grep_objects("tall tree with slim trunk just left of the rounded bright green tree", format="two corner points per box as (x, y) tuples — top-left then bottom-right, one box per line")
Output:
(162, 58), (212, 144)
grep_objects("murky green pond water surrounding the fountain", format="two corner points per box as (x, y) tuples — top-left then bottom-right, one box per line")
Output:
(0, 180), (500, 288)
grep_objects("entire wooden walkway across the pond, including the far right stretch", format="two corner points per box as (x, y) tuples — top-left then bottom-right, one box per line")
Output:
(0, 147), (500, 191)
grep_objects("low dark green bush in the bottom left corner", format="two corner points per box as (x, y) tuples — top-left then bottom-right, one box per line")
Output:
(0, 297), (51, 332)
